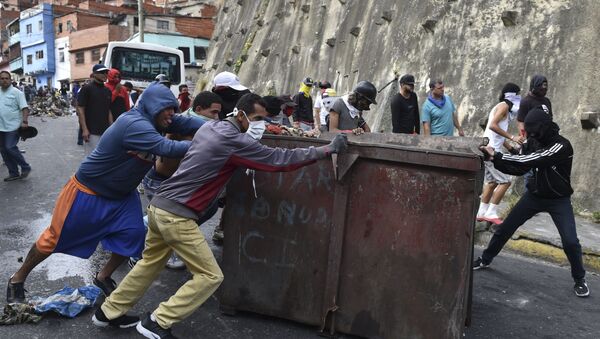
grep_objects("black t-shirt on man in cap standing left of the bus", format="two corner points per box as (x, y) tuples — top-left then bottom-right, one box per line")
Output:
(77, 81), (112, 135)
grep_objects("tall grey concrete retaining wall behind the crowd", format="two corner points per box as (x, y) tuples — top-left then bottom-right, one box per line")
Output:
(205, 0), (600, 210)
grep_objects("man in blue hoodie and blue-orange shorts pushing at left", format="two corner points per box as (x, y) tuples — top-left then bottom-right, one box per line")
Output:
(7, 84), (203, 314)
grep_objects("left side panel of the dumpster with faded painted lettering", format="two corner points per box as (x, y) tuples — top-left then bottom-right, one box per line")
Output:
(218, 160), (335, 325)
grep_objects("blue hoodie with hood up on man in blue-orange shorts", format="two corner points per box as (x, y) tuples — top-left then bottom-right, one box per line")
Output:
(75, 83), (203, 199)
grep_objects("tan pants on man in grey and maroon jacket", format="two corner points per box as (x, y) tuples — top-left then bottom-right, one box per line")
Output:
(102, 205), (223, 329)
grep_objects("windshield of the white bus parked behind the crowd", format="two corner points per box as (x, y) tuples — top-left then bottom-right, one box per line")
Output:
(110, 47), (181, 84)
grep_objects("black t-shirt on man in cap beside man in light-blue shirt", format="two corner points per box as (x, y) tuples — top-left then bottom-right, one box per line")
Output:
(391, 93), (421, 134)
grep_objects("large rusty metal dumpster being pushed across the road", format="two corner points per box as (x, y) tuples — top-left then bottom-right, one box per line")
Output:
(218, 133), (483, 339)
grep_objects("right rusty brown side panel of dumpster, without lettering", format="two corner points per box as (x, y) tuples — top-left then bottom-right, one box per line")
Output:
(336, 159), (476, 338)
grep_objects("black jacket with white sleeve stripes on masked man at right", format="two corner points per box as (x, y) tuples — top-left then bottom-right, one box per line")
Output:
(493, 135), (573, 198)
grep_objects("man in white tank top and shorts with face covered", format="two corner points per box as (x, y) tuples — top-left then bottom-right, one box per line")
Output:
(477, 83), (523, 224)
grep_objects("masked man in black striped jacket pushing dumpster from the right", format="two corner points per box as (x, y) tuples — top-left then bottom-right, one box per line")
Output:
(473, 108), (590, 297)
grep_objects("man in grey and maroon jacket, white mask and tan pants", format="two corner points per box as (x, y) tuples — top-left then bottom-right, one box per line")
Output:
(92, 93), (347, 338)
